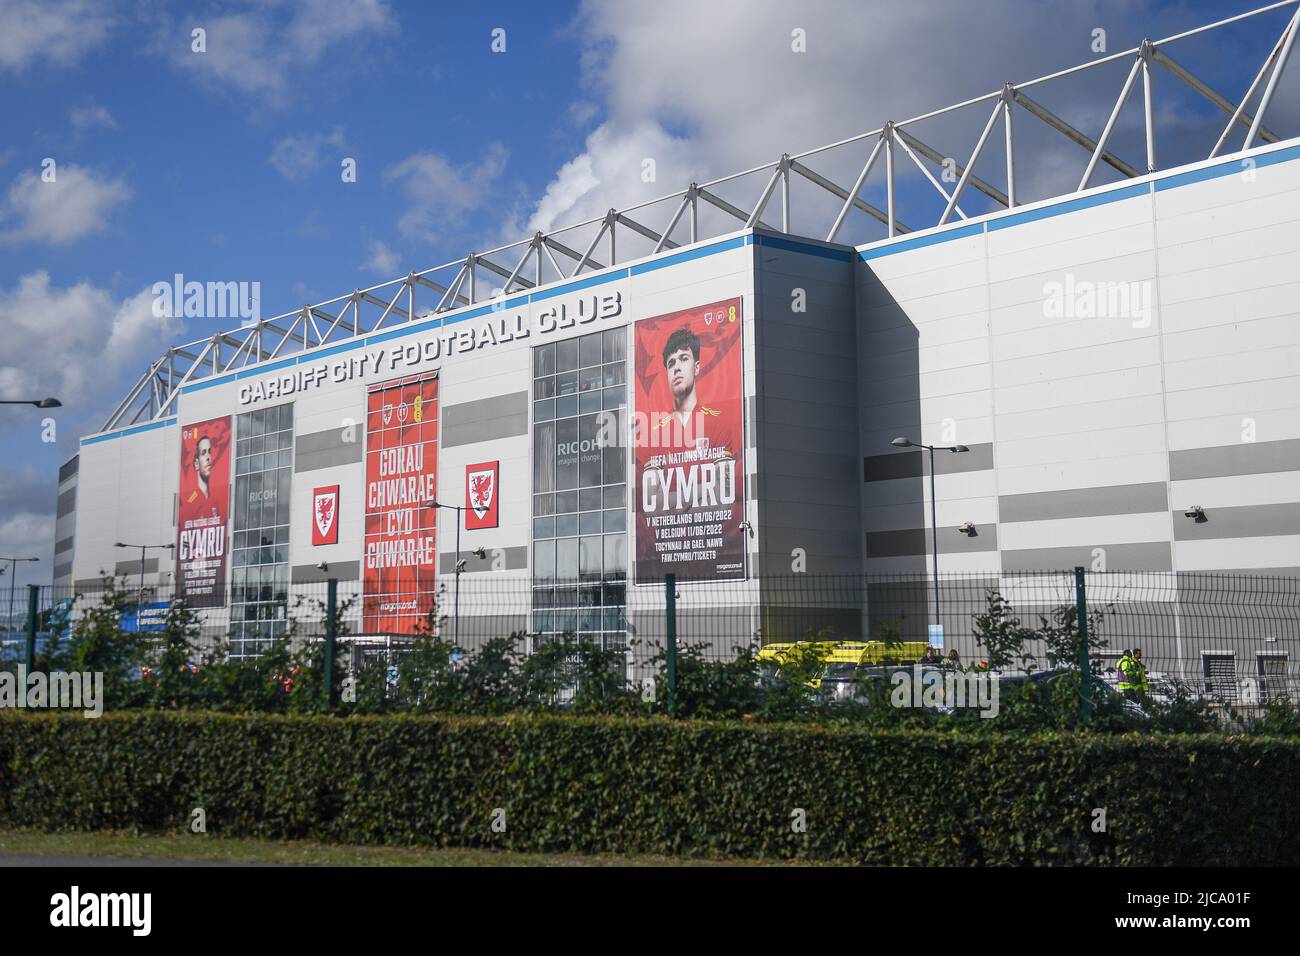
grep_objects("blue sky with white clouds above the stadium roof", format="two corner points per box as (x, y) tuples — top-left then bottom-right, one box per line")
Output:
(0, 0), (1300, 584)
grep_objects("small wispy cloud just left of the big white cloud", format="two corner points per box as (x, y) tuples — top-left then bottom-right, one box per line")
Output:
(384, 143), (510, 242)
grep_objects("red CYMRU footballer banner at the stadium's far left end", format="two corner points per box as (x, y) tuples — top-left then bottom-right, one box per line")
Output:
(176, 415), (230, 607)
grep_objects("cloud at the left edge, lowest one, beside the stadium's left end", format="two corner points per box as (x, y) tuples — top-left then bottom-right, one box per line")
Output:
(0, 271), (183, 418)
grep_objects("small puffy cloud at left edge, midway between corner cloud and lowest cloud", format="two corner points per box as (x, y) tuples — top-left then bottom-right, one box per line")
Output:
(0, 164), (131, 245)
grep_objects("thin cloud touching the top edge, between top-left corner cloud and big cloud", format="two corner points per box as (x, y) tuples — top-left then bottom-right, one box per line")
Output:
(165, 0), (394, 101)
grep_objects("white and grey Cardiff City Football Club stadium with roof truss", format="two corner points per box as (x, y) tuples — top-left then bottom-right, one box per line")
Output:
(56, 5), (1300, 666)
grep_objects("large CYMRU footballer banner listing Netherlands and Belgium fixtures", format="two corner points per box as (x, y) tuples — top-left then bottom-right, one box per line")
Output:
(633, 298), (745, 584)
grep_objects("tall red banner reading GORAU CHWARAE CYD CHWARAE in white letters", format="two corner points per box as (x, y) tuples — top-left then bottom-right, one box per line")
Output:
(361, 373), (438, 633)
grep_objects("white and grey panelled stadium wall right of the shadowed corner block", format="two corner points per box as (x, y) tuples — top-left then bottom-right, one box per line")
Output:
(857, 144), (1300, 574)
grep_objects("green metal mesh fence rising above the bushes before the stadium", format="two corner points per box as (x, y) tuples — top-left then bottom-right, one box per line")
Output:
(10, 571), (1300, 702)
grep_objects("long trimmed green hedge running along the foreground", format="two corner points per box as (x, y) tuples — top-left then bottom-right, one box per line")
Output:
(0, 713), (1300, 865)
